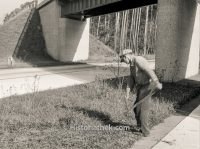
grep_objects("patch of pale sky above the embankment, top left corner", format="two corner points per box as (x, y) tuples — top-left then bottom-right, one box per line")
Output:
(0, 0), (41, 24)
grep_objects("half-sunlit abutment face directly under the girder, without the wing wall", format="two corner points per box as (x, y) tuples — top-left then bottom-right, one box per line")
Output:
(58, 18), (90, 61)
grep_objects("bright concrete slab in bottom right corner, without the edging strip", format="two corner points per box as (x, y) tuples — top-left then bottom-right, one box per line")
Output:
(152, 97), (200, 149)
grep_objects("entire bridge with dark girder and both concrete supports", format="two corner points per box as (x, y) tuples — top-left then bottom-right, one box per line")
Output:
(38, 0), (200, 82)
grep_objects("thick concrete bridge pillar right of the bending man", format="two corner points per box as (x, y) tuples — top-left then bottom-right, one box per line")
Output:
(156, 0), (200, 82)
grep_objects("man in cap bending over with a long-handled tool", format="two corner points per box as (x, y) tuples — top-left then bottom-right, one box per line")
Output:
(120, 49), (162, 136)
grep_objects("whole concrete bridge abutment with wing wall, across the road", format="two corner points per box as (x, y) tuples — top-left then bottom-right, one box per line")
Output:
(38, 0), (89, 62)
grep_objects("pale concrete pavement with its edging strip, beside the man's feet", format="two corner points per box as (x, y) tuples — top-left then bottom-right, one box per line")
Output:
(131, 96), (200, 149)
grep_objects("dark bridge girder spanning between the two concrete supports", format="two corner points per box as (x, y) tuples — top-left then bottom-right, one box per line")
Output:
(61, 0), (158, 19)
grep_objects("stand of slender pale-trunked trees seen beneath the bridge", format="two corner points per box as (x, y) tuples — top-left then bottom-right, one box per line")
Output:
(90, 5), (157, 54)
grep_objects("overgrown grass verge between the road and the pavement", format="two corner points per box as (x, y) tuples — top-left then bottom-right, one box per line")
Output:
(0, 67), (199, 149)
